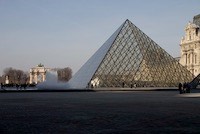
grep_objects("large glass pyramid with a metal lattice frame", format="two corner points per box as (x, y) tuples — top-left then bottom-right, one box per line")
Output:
(69, 20), (194, 88)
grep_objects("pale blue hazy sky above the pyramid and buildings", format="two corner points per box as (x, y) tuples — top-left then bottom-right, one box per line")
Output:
(0, 0), (200, 75)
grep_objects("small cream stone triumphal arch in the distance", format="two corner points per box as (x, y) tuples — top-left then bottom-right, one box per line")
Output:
(29, 64), (51, 84)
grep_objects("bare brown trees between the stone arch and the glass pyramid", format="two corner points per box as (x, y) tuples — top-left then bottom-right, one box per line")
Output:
(57, 67), (72, 82)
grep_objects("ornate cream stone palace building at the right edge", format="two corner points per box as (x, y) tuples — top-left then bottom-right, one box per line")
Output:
(180, 14), (200, 76)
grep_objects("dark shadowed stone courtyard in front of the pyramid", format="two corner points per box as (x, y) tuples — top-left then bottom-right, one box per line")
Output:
(0, 91), (200, 134)
